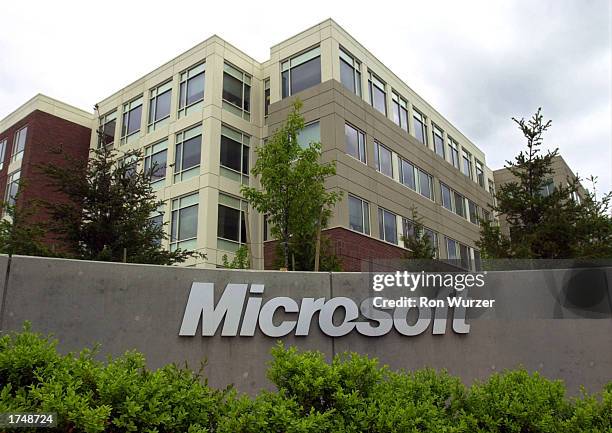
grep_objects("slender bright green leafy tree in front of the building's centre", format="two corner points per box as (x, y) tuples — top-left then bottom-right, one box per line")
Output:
(242, 100), (341, 270)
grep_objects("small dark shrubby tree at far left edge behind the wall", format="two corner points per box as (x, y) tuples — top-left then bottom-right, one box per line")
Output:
(0, 182), (53, 256)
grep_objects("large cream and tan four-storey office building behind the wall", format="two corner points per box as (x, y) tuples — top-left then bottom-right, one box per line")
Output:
(91, 19), (502, 271)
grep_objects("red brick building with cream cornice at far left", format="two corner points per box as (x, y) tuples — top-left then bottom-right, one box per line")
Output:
(0, 94), (93, 250)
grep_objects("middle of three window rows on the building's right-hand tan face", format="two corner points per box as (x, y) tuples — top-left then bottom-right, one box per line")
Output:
(344, 123), (486, 214)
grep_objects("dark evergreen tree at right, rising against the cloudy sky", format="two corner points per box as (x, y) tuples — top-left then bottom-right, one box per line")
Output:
(477, 109), (612, 259)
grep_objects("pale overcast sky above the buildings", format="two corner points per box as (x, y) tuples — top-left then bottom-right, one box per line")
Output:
(0, 0), (612, 194)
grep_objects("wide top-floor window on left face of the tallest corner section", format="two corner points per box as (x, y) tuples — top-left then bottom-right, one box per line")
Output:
(281, 47), (321, 98)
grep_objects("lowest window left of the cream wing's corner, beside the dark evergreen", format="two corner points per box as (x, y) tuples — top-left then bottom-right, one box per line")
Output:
(170, 193), (199, 251)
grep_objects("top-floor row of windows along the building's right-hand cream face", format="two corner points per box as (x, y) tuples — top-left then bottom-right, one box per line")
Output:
(340, 48), (485, 188)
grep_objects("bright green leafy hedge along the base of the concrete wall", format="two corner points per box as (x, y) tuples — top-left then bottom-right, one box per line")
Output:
(0, 326), (612, 433)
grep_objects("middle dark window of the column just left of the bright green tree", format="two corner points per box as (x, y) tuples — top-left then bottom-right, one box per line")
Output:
(219, 125), (251, 185)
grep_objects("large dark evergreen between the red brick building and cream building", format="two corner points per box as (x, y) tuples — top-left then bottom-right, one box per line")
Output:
(41, 121), (203, 265)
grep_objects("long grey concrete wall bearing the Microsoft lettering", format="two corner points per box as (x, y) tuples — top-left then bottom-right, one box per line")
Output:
(0, 256), (612, 394)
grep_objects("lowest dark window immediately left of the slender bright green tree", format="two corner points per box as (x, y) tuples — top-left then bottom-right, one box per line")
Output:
(217, 193), (247, 252)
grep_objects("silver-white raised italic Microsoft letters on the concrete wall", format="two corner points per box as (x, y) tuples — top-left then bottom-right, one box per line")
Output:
(179, 282), (470, 337)
